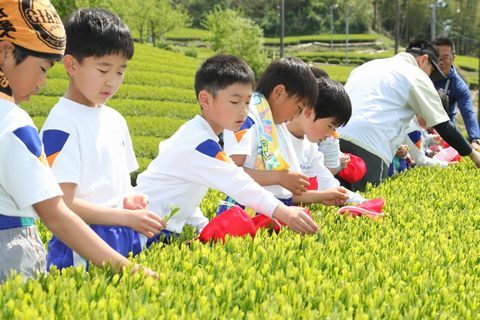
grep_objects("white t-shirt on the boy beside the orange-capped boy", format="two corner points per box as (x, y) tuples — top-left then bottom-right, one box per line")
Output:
(41, 98), (138, 208)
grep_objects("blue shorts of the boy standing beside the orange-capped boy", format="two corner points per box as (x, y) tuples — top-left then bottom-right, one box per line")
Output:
(47, 225), (142, 270)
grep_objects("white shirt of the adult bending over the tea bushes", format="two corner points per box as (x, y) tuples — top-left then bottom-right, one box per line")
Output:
(337, 53), (449, 165)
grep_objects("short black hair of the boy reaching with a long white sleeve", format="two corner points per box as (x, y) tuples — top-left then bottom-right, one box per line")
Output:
(195, 54), (255, 98)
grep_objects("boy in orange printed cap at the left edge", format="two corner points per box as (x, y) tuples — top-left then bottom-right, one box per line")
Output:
(0, 0), (155, 282)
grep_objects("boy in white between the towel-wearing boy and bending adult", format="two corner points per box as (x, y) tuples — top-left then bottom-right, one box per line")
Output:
(287, 78), (365, 205)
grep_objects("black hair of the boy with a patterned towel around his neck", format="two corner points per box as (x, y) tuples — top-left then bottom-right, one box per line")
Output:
(256, 57), (318, 106)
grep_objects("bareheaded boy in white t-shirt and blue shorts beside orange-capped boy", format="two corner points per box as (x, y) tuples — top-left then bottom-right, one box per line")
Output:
(41, 9), (164, 269)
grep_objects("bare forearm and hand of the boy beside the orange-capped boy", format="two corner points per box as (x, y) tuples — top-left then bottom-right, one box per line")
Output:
(60, 183), (166, 237)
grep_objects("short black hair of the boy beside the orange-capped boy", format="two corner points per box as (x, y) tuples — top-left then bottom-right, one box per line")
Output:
(65, 8), (134, 62)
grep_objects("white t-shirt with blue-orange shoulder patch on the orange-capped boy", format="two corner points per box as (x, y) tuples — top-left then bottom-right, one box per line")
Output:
(0, 99), (62, 218)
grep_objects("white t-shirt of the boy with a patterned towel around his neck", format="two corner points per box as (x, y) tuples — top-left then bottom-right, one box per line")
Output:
(223, 115), (300, 199)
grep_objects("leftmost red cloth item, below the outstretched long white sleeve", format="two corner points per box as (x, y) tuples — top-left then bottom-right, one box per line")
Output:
(198, 206), (257, 243)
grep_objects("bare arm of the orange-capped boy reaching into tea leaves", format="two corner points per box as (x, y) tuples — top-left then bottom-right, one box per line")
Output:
(33, 196), (158, 277)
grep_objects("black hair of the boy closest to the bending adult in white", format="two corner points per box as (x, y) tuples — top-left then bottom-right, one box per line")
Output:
(314, 78), (352, 126)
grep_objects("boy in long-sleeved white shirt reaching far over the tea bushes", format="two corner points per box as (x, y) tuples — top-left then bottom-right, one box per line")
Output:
(137, 55), (318, 246)
